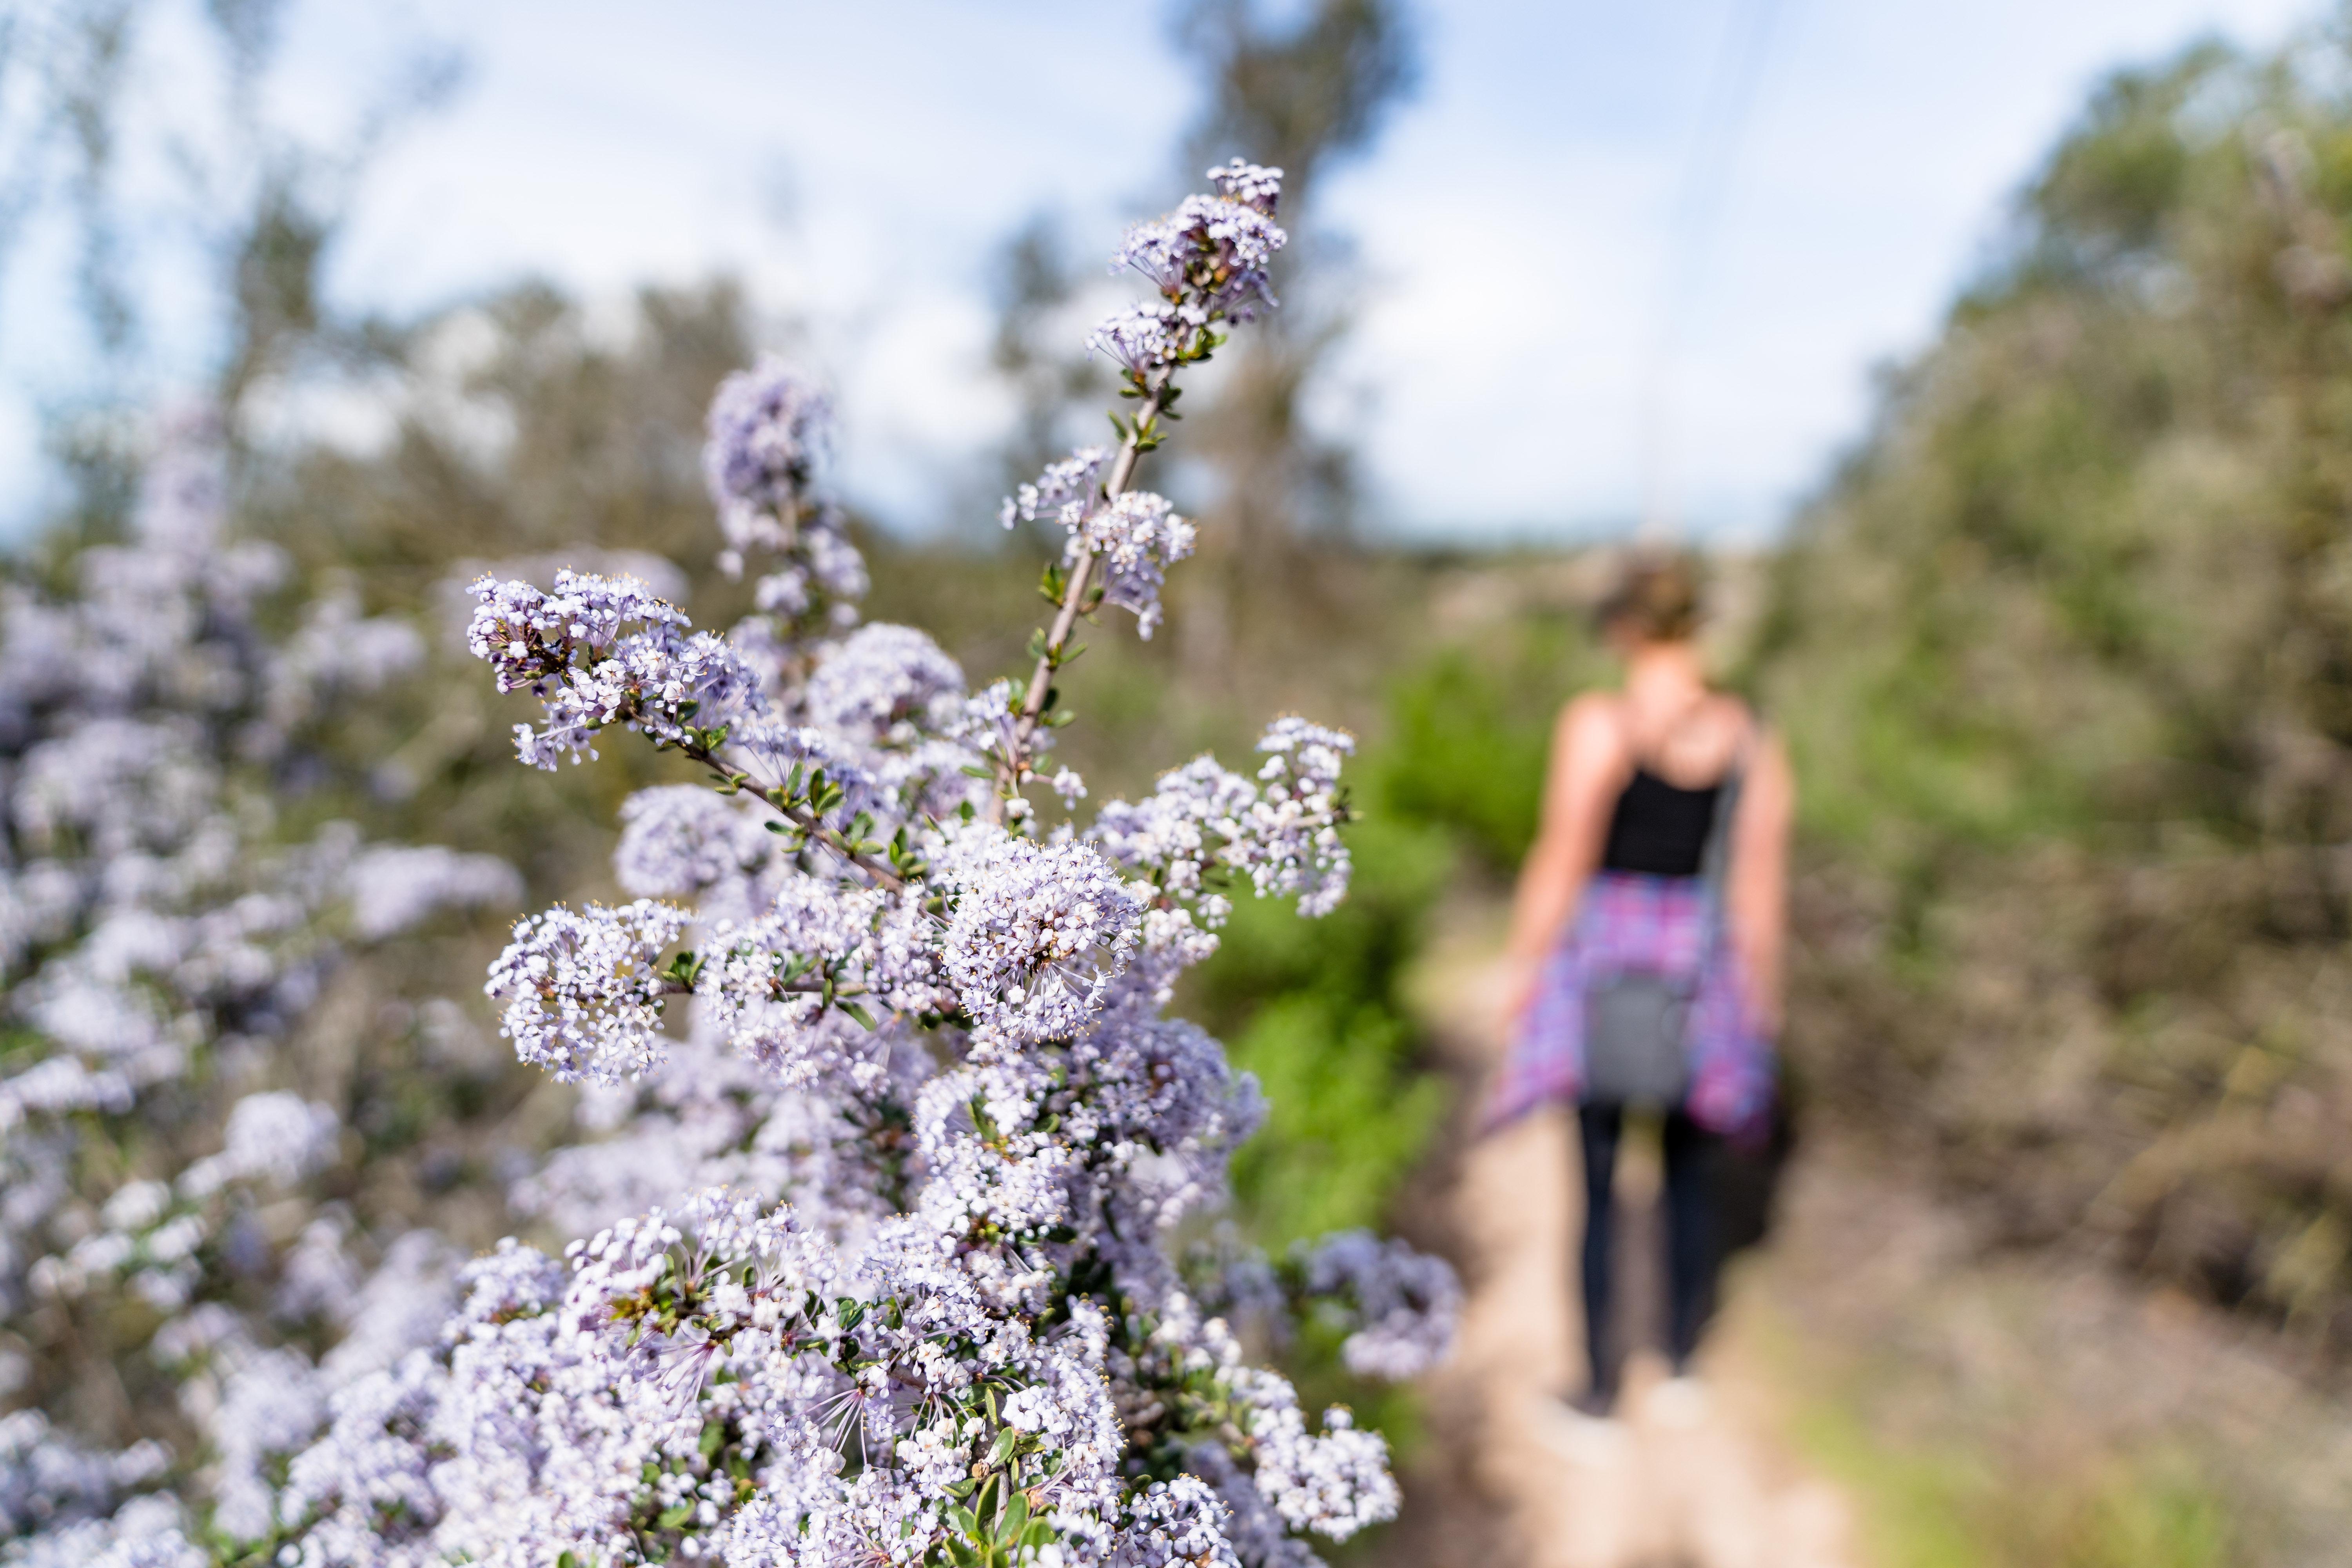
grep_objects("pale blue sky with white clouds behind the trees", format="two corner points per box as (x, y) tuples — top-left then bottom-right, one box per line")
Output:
(0, 0), (2310, 541)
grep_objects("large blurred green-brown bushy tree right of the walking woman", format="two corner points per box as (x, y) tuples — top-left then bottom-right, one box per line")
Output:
(1762, 21), (2352, 1352)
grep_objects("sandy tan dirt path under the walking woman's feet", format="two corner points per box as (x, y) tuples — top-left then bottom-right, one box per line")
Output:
(1416, 917), (1856, 1568)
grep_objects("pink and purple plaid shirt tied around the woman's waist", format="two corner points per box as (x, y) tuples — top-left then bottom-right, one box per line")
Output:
(1482, 872), (1773, 1133)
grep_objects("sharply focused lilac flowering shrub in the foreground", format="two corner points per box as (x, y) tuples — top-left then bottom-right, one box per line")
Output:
(270, 162), (1456, 1568)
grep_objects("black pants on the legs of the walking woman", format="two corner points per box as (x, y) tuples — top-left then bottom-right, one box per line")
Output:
(1576, 1105), (1722, 1396)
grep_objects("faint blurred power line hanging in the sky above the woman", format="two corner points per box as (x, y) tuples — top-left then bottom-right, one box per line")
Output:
(1639, 0), (1780, 538)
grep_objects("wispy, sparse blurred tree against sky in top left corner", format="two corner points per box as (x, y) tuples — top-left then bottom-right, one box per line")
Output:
(0, 0), (461, 552)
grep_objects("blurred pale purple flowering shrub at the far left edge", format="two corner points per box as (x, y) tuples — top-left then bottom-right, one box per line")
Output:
(0, 414), (522, 1563)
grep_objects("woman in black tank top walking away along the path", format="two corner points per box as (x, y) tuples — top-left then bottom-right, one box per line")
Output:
(1486, 557), (1795, 1415)
